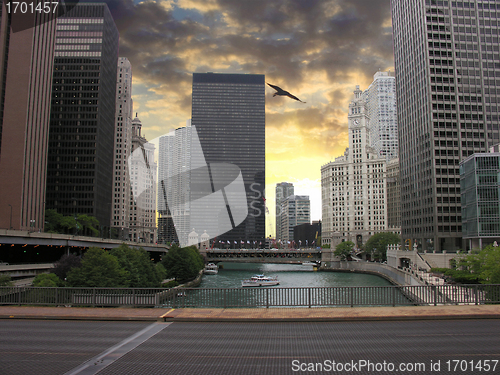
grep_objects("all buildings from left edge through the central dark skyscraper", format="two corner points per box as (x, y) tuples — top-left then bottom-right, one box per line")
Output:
(0, 3), (265, 248)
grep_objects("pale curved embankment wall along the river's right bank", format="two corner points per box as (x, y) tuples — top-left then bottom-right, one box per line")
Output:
(320, 261), (424, 285)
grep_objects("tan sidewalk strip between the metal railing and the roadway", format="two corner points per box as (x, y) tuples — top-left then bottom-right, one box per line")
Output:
(0, 305), (500, 322)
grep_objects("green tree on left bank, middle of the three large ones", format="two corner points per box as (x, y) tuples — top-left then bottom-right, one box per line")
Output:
(110, 244), (165, 288)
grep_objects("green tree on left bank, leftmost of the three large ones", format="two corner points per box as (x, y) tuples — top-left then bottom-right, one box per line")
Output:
(67, 247), (128, 288)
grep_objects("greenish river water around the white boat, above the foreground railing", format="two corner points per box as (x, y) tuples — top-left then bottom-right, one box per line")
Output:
(199, 263), (392, 288)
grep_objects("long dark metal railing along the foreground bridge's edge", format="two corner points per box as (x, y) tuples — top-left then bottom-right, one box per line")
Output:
(0, 284), (500, 308)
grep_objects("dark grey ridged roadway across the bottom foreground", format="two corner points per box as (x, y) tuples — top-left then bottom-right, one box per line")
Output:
(0, 319), (500, 375)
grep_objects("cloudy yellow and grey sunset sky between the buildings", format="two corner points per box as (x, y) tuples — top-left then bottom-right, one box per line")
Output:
(100, 0), (394, 236)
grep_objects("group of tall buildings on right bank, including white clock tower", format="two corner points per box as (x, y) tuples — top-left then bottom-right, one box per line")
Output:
(321, 0), (500, 251)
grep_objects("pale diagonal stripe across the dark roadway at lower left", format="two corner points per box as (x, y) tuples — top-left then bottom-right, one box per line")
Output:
(64, 323), (172, 375)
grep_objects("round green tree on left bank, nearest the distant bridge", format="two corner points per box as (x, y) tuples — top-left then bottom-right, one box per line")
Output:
(162, 245), (205, 281)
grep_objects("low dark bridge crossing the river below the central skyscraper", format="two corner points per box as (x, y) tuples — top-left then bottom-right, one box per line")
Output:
(202, 248), (321, 265)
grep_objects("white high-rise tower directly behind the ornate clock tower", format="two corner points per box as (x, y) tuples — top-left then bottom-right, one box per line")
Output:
(363, 72), (399, 161)
